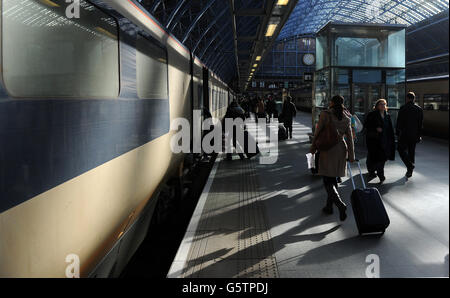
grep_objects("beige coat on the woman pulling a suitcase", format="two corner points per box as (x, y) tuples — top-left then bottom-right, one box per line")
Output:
(310, 108), (355, 177)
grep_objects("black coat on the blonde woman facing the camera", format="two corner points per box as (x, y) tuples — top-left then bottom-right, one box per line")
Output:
(364, 110), (395, 161)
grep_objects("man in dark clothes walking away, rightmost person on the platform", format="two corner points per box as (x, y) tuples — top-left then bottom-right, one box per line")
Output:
(396, 92), (423, 178)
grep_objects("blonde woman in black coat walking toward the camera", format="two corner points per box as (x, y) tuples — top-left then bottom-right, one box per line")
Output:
(364, 99), (395, 183)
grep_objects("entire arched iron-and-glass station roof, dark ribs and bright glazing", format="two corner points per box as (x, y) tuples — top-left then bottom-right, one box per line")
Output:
(139, 0), (449, 90)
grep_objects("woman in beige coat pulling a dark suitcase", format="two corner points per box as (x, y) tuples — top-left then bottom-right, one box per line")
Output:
(310, 95), (355, 221)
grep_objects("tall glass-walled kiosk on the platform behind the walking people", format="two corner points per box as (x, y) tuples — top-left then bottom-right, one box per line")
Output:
(312, 22), (406, 139)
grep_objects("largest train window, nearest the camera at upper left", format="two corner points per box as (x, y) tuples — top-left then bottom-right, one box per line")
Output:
(1, 0), (120, 98)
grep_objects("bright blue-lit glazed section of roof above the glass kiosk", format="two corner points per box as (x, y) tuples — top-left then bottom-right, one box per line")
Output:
(278, 0), (448, 39)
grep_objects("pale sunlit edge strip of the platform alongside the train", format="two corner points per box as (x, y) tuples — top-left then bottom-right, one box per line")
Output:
(167, 154), (223, 278)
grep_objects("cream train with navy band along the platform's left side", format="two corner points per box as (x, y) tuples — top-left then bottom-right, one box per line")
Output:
(0, 0), (236, 277)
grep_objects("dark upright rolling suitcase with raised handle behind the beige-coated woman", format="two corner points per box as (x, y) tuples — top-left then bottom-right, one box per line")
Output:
(347, 161), (390, 235)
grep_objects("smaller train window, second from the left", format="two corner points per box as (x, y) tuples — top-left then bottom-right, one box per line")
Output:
(136, 35), (169, 99)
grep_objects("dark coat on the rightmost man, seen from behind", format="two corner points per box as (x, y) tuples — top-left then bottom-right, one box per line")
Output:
(396, 101), (423, 142)
